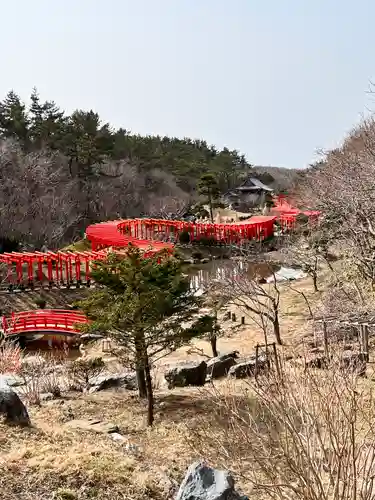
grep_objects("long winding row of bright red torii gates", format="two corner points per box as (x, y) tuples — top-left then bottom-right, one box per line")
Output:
(0, 198), (319, 290)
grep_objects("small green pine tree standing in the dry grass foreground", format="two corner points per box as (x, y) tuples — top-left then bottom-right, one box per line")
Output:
(80, 247), (201, 425)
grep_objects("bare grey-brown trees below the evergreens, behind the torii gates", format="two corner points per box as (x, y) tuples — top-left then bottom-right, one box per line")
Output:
(0, 140), (192, 249)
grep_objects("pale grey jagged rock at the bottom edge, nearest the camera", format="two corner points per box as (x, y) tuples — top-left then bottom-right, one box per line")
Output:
(176, 462), (248, 500)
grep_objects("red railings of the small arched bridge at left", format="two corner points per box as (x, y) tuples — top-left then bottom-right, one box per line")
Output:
(2, 309), (89, 335)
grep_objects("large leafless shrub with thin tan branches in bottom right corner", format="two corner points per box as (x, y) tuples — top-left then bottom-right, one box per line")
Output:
(192, 357), (375, 500)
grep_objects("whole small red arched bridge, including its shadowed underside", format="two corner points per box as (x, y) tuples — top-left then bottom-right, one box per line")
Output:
(1, 309), (89, 345)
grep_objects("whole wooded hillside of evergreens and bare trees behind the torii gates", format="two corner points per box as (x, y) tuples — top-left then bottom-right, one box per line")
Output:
(0, 89), (254, 248)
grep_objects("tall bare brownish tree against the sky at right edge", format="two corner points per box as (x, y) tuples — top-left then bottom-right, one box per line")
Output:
(297, 117), (375, 287)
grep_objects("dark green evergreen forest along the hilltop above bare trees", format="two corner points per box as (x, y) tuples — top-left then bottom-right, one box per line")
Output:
(0, 89), (250, 192)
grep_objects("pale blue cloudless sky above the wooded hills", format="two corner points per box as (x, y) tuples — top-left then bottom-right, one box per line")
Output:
(0, 0), (375, 168)
